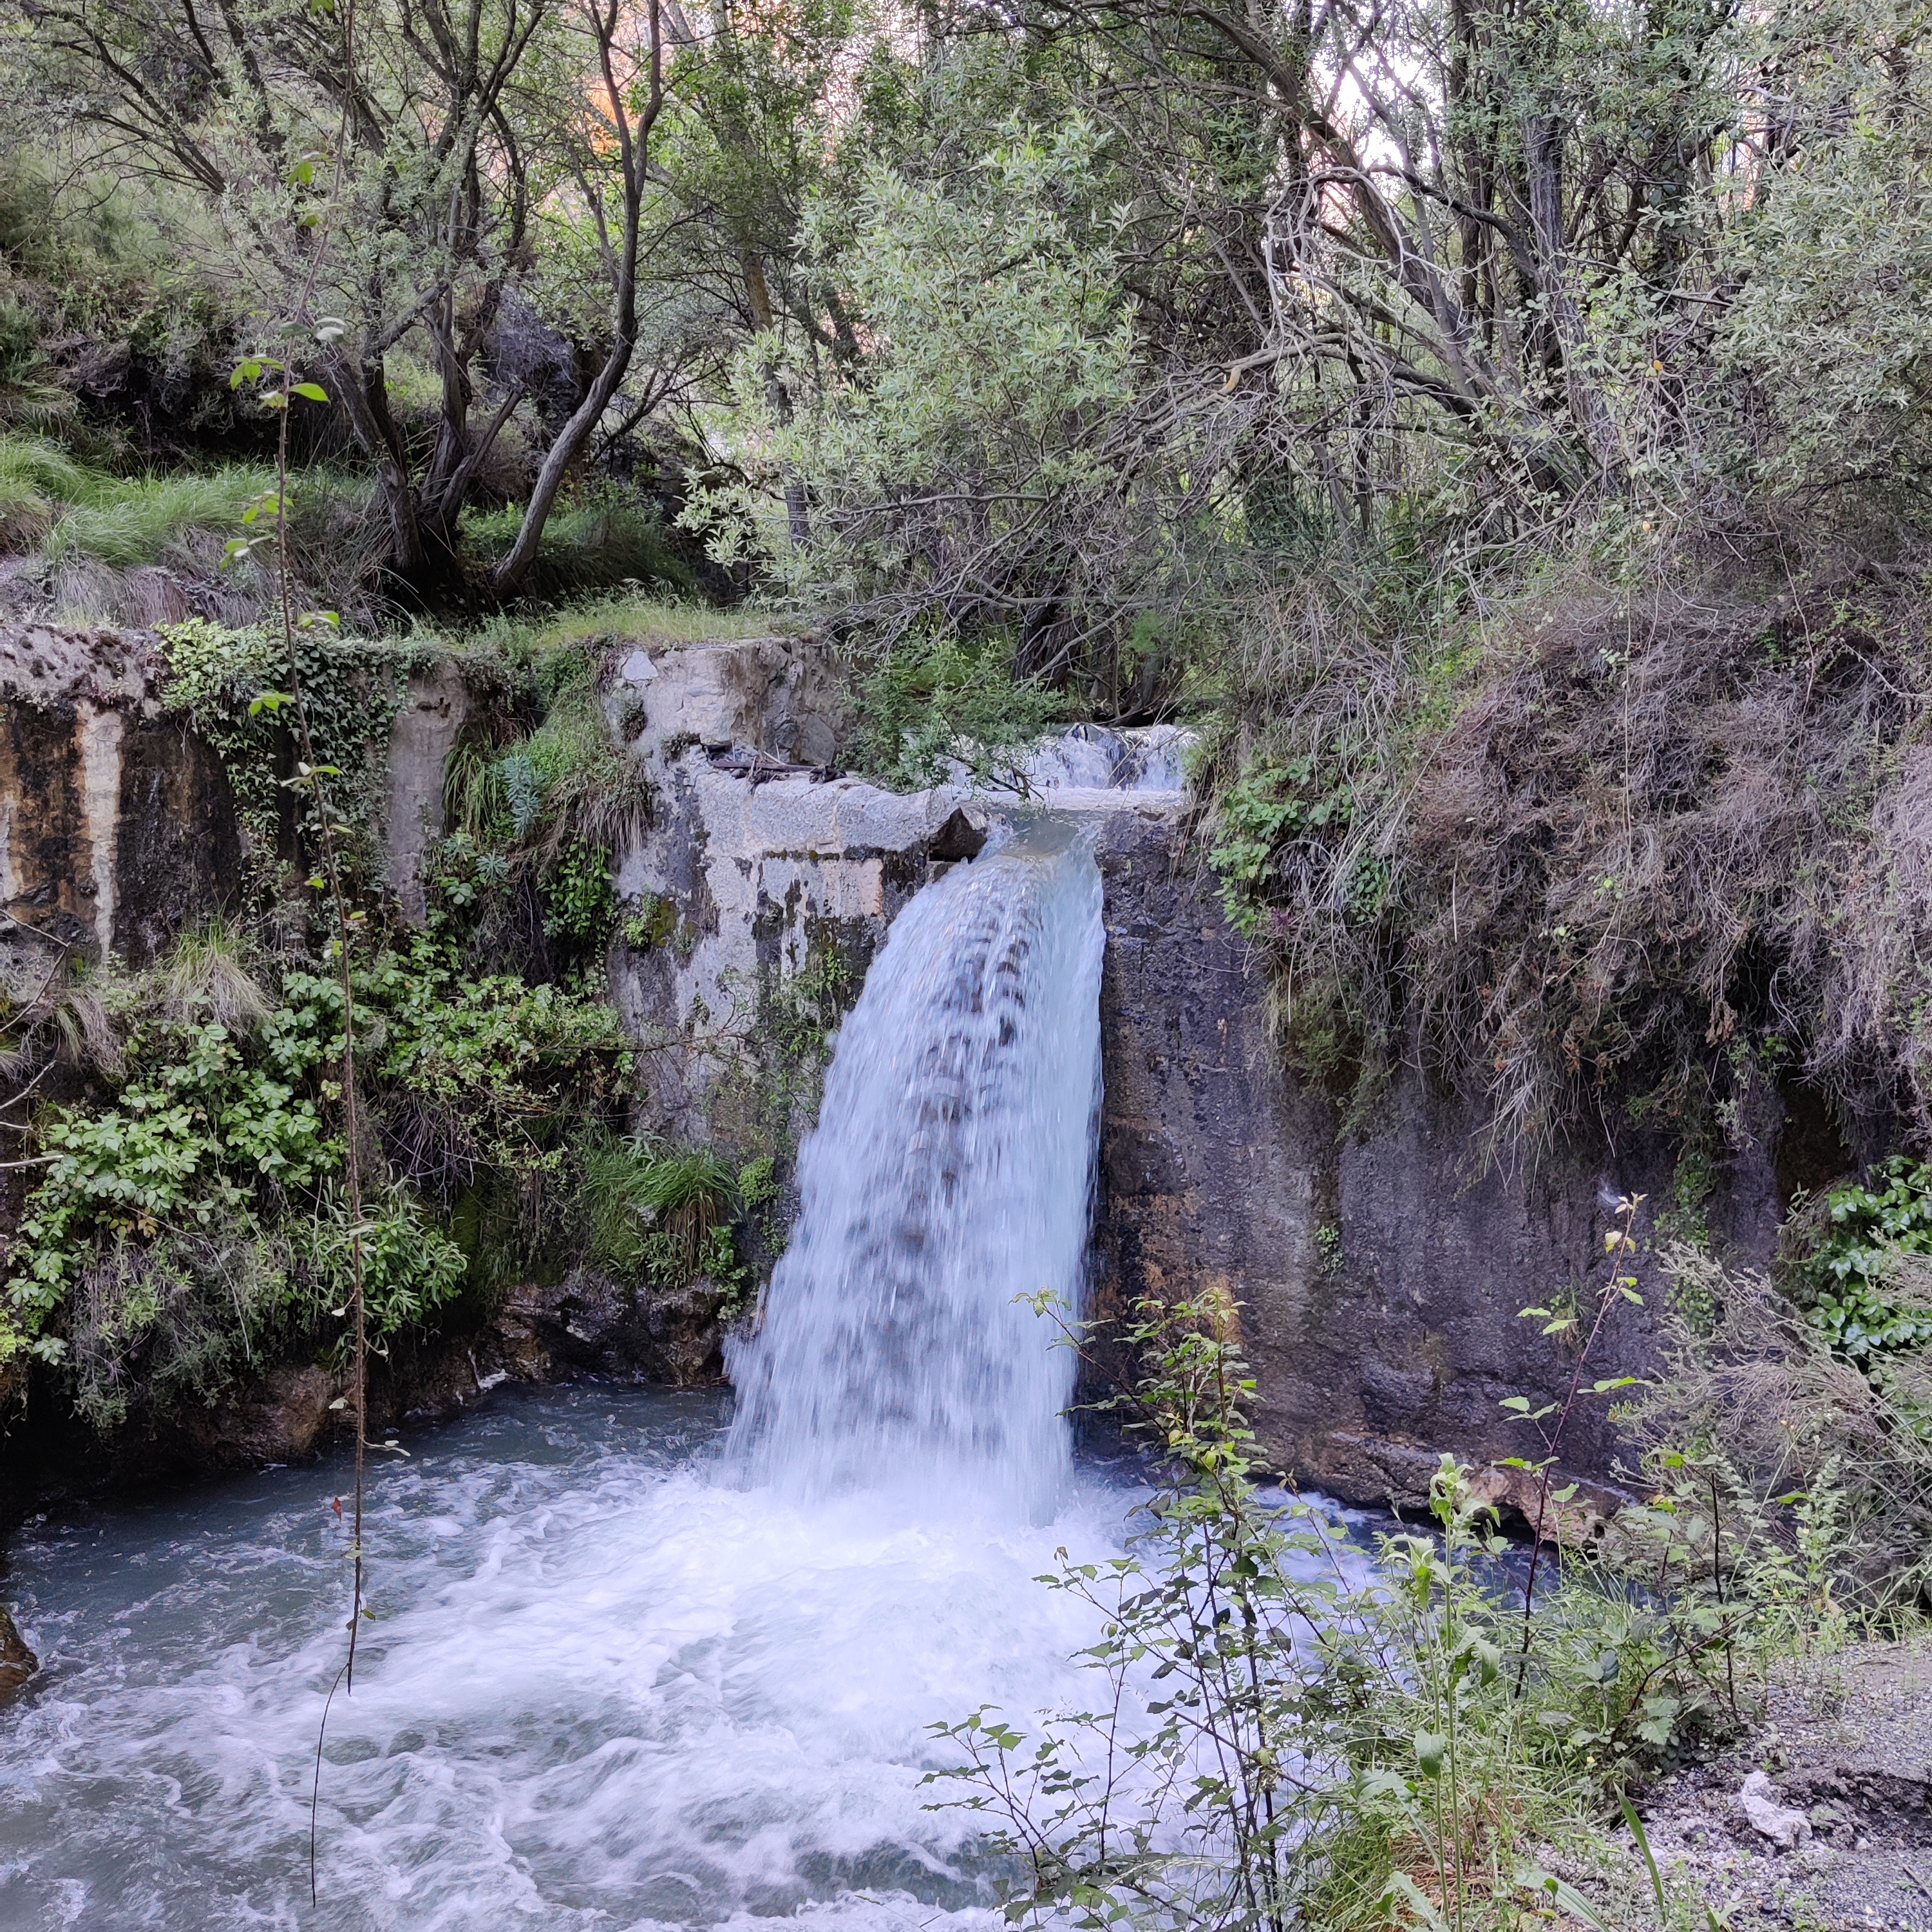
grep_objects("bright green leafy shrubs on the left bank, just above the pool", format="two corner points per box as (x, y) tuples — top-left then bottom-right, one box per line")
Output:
(0, 931), (630, 1426)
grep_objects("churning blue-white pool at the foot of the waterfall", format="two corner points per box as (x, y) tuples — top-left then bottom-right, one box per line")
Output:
(0, 1385), (1128, 1932)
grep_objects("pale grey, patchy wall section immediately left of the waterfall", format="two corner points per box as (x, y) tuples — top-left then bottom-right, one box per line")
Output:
(611, 639), (960, 1150)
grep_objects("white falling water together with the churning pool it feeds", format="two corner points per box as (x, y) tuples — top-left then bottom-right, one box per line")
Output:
(0, 833), (1128, 1932)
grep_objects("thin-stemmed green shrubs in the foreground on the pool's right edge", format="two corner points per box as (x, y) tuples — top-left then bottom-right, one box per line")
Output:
(933, 1298), (1785, 1932)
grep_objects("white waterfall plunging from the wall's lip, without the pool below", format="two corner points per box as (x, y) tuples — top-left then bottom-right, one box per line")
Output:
(728, 821), (1103, 1520)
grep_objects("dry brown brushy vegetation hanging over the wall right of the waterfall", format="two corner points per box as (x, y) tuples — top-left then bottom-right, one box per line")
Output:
(1221, 566), (1932, 1150)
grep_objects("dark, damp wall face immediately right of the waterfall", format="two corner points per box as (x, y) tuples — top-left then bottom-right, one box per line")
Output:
(1097, 811), (1656, 1505)
